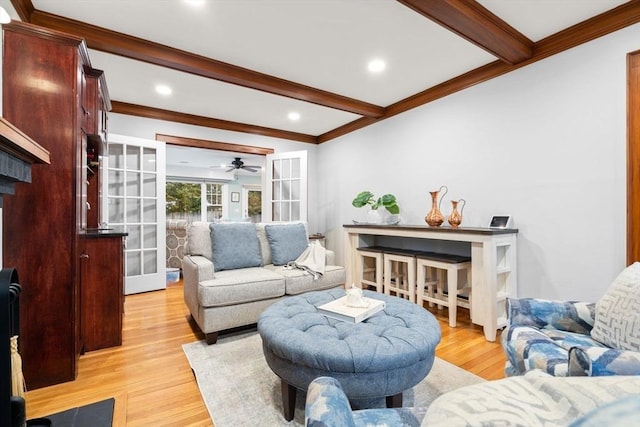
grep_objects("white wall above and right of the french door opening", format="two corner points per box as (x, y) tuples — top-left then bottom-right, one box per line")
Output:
(107, 115), (323, 233)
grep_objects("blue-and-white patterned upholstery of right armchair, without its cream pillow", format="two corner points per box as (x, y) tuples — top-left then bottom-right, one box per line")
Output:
(501, 298), (640, 376)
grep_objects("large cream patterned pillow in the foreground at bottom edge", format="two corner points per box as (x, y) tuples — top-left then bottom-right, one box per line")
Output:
(422, 371), (640, 427)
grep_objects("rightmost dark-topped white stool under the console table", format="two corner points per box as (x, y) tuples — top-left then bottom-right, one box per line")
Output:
(416, 252), (471, 328)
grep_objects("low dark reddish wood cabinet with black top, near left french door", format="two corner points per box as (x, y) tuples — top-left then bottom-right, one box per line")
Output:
(80, 233), (124, 351)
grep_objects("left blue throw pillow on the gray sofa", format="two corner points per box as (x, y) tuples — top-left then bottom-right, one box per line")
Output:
(209, 222), (262, 271)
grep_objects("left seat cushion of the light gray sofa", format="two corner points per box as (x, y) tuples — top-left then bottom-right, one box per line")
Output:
(198, 267), (285, 308)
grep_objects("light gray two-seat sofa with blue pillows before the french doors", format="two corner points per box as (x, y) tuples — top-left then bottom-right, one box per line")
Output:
(182, 222), (345, 344)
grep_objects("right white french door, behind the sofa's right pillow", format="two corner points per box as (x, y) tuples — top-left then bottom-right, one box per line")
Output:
(262, 151), (307, 222)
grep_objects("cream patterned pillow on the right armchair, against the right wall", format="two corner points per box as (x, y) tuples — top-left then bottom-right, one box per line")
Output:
(591, 262), (640, 351)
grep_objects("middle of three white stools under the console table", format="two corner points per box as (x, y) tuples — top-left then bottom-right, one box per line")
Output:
(383, 249), (416, 302)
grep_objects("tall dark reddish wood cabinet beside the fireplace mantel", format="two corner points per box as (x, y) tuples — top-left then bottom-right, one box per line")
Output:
(2, 21), (122, 389)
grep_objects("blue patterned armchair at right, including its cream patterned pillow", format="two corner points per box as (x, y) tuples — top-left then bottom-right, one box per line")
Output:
(501, 263), (640, 376)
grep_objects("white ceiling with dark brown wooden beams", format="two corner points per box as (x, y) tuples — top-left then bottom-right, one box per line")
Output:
(0, 0), (640, 143)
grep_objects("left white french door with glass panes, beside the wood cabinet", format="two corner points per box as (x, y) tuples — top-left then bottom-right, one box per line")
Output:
(103, 134), (166, 295)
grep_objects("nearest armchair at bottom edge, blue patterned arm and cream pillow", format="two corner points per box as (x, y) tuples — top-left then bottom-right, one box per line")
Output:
(305, 370), (640, 427)
